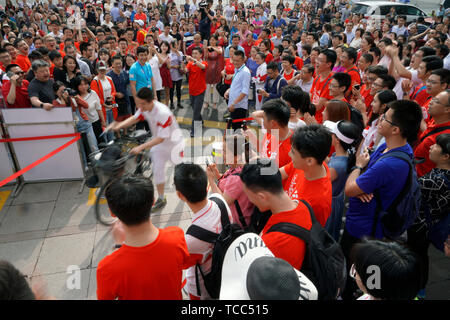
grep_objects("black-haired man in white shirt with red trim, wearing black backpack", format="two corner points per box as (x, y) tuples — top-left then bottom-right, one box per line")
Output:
(174, 163), (233, 300)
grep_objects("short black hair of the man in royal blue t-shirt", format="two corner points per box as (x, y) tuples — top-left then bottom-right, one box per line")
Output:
(387, 100), (423, 145)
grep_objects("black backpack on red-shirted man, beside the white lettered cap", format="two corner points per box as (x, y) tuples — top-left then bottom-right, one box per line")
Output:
(267, 200), (347, 300)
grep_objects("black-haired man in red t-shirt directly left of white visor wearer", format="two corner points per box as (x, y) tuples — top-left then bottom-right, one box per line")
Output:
(280, 125), (332, 227)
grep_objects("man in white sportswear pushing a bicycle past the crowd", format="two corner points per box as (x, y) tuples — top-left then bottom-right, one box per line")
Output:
(107, 87), (184, 211)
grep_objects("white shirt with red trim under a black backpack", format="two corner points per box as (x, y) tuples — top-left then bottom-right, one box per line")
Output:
(185, 193), (233, 299)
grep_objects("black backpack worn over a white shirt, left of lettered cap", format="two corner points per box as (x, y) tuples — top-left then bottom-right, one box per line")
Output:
(186, 197), (246, 299)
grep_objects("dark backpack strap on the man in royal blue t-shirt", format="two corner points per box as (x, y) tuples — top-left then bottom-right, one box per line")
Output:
(372, 151), (414, 237)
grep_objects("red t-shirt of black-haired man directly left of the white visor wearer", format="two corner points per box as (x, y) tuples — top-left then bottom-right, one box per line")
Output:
(283, 162), (332, 227)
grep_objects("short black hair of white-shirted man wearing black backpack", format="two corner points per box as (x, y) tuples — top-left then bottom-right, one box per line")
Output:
(173, 163), (208, 203)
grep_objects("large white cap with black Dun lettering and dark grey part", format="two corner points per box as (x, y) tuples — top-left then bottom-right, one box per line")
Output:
(220, 233), (318, 300)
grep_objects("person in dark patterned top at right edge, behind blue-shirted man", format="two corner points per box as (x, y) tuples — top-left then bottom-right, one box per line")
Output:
(407, 133), (450, 299)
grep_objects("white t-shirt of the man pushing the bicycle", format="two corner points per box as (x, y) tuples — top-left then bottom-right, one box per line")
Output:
(134, 100), (183, 149)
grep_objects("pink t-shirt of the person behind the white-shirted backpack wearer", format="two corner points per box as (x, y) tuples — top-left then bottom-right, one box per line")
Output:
(218, 167), (254, 226)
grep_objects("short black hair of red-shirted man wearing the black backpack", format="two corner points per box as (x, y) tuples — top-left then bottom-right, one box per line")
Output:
(240, 159), (283, 194)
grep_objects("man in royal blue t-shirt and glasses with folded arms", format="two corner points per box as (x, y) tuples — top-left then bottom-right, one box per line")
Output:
(341, 100), (422, 299)
